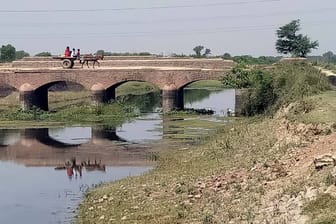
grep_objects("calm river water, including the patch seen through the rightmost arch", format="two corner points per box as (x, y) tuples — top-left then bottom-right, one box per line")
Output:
(0, 90), (235, 224)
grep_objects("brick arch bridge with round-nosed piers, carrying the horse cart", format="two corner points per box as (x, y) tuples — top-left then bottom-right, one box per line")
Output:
(0, 57), (234, 112)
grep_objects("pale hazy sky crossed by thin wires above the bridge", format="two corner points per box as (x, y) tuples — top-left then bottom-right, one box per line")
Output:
(0, 0), (336, 56)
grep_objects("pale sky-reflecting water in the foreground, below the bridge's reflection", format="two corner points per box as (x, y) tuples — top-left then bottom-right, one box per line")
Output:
(0, 162), (149, 224)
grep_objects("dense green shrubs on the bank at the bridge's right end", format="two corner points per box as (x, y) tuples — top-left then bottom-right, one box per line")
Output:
(222, 62), (331, 116)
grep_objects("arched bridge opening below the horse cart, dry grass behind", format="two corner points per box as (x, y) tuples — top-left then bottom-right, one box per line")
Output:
(35, 81), (91, 110)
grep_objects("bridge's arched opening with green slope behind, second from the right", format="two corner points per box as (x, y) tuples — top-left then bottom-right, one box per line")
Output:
(107, 81), (162, 112)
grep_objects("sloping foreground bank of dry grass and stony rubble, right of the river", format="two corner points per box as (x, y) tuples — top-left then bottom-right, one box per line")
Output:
(78, 62), (336, 224)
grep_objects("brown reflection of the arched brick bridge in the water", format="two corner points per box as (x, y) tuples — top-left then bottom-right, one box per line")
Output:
(0, 127), (159, 171)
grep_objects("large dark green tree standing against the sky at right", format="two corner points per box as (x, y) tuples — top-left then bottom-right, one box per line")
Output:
(275, 20), (319, 57)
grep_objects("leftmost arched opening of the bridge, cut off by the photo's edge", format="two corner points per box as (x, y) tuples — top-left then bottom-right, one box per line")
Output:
(0, 84), (19, 108)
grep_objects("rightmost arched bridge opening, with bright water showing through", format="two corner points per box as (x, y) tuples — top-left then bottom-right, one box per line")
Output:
(183, 80), (235, 116)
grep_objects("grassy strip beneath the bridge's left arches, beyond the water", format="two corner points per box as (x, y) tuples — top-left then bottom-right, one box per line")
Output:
(0, 82), (163, 127)
